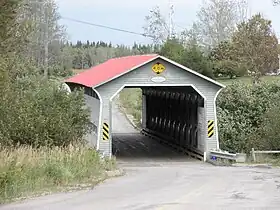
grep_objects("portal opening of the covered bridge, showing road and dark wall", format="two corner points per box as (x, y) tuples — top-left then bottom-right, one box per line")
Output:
(110, 86), (205, 159)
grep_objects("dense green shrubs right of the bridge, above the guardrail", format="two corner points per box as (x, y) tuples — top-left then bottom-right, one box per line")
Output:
(217, 82), (280, 153)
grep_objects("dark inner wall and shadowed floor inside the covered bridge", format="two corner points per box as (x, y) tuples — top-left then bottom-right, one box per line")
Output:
(112, 86), (204, 160)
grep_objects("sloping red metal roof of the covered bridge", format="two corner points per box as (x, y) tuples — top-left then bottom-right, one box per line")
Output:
(66, 54), (158, 87)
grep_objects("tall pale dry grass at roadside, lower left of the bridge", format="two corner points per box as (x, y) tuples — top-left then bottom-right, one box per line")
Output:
(0, 146), (116, 203)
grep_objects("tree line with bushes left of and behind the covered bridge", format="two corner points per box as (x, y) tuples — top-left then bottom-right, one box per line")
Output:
(0, 0), (278, 149)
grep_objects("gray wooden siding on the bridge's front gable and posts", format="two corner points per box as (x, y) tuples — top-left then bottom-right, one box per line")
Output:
(96, 59), (221, 155)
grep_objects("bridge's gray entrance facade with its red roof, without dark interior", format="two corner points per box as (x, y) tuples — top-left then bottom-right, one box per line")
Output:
(66, 55), (225, 161)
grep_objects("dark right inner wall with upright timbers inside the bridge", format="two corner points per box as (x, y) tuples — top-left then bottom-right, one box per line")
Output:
(143, 87), (204, 148)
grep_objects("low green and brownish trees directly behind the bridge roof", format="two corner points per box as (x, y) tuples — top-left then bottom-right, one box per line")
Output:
(68, 9), (279, 81)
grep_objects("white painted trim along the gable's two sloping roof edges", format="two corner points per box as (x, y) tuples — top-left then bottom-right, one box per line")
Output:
(94, 55), (225, 88)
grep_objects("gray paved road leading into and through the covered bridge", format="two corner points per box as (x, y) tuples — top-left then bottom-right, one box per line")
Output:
(0, 99), (280, 210)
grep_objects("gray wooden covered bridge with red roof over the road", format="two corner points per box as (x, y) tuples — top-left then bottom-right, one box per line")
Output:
(66, 54), (224, 161)
